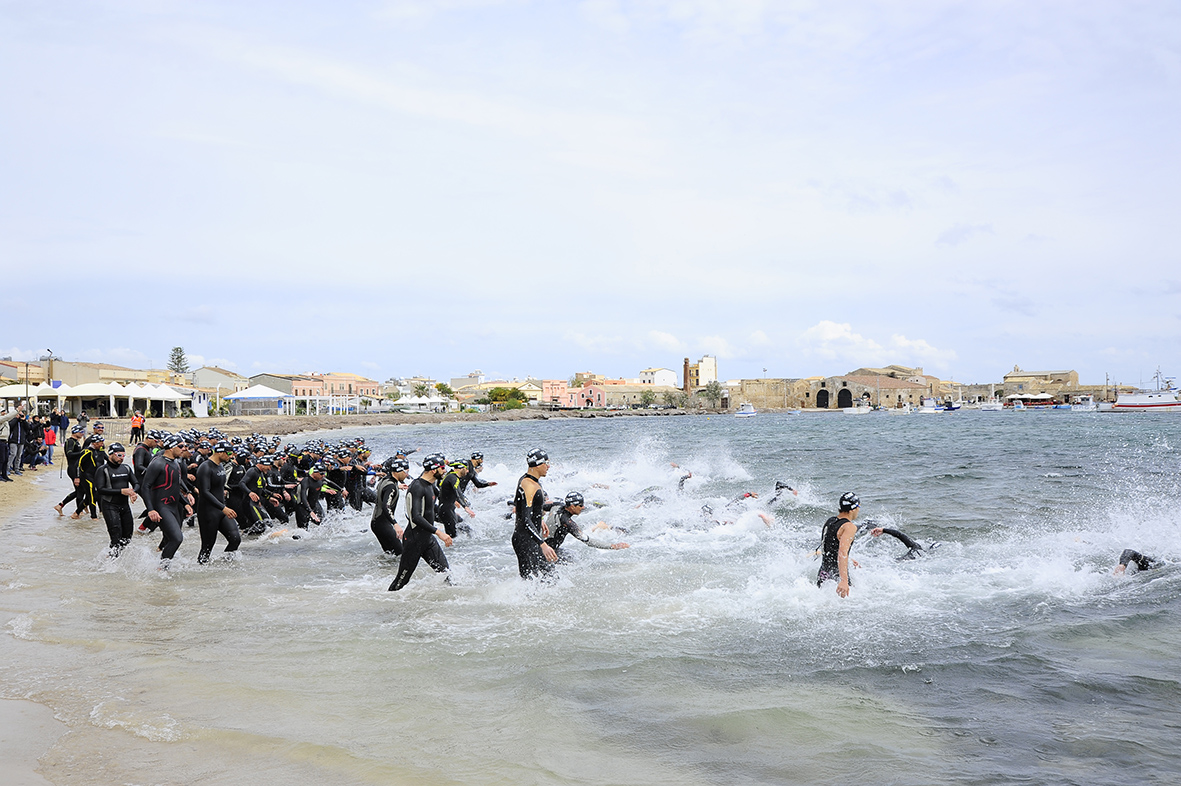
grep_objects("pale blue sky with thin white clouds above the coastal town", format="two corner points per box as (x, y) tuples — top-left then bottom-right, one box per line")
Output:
(0, 0), (1181, 384)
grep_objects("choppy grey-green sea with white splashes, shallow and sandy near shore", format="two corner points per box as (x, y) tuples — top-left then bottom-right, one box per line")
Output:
(0, 411), (1181, 786)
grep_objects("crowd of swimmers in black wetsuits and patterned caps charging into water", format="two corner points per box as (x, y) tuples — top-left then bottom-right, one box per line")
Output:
(11, 410), (1164, 597)
